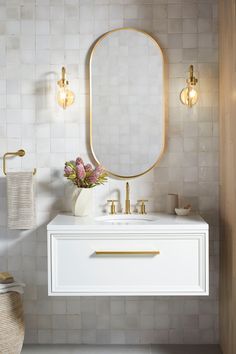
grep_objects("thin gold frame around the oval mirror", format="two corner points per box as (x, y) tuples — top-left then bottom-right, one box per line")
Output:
(89, 27), (167, 179)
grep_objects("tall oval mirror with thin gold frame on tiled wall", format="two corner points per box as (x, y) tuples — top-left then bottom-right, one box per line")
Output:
(90, 28), (165, 178)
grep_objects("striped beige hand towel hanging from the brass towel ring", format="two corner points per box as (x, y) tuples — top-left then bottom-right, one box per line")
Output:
(7, 172), (35, 229)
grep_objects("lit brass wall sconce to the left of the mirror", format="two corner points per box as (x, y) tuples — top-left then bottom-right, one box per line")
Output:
(57, 66), (75, 109)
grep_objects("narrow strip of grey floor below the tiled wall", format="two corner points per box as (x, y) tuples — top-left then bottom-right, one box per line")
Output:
(22, 344), (222, 354)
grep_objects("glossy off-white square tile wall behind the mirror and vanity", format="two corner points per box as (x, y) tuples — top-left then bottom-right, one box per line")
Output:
(0, 0), (219, 344)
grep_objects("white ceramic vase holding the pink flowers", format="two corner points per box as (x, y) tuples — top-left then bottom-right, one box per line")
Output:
(72, 188), (93, 216)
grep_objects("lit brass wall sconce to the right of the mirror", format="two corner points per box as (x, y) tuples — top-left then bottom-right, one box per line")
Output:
(180, 65), (198, 108)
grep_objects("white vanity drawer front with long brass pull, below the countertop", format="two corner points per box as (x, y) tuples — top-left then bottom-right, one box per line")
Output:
(48, 233), (208, 296)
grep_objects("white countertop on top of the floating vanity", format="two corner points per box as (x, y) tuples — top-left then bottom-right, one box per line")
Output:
(47, 213), (208, 232)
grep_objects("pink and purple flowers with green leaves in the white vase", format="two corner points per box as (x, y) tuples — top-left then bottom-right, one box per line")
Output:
(64, 157), (107, 188)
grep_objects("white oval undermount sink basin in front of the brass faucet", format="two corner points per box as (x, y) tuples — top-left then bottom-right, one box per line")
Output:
(96, 214), (157, 224)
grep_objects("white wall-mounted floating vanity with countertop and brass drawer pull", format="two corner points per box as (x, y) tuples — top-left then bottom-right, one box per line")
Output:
(47, 214), (209, 296)
